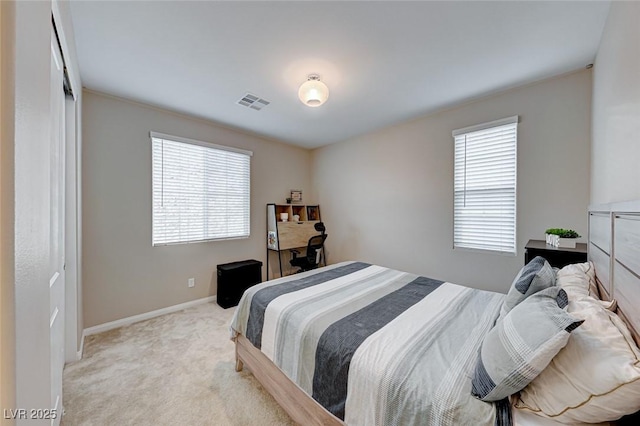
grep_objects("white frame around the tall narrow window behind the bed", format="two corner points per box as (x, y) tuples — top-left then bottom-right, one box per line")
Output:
(452, 115), (520, 257)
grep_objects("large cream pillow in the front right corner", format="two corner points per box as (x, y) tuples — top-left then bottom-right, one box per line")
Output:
(516, 297), (640, 423)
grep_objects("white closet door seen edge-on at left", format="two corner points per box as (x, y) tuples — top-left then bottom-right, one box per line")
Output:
(49, 29), (65, 425)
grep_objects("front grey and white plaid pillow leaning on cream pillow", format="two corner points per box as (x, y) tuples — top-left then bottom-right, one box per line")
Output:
(471, 287), (582, 401)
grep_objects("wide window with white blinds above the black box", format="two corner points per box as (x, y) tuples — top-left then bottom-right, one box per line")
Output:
(151, 132), (253, 246)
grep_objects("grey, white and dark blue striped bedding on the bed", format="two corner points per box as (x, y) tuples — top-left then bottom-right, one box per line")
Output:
(231, 262), (510, 426)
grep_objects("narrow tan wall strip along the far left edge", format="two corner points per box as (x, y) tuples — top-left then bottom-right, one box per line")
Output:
(0, 2), (16, 425)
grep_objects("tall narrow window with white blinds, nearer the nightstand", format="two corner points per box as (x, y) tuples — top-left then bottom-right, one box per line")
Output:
(453, 116), (518, 255)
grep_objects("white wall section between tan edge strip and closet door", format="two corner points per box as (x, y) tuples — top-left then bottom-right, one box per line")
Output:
(12, 1), (51, 418)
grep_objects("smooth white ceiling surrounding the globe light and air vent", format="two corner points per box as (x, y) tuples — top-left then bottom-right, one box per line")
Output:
(71, 1), (609, 148)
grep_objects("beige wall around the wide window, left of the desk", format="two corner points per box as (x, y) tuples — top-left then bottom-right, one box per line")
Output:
(82, 91), (311, 327)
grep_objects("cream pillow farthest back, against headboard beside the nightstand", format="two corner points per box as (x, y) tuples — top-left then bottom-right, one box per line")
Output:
(556, 262), (617, 311)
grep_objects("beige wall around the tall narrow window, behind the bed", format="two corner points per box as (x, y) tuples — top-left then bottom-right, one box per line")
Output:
(312, 70), (591, 292)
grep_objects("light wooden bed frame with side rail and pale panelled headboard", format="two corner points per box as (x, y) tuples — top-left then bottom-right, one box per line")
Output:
(235, 201), (640, 426)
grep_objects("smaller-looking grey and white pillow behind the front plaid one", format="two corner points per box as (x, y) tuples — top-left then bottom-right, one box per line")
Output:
(500, 256), (556, 319)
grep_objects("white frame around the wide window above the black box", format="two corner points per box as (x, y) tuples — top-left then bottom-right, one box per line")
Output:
(149, 131), (253, 247)
